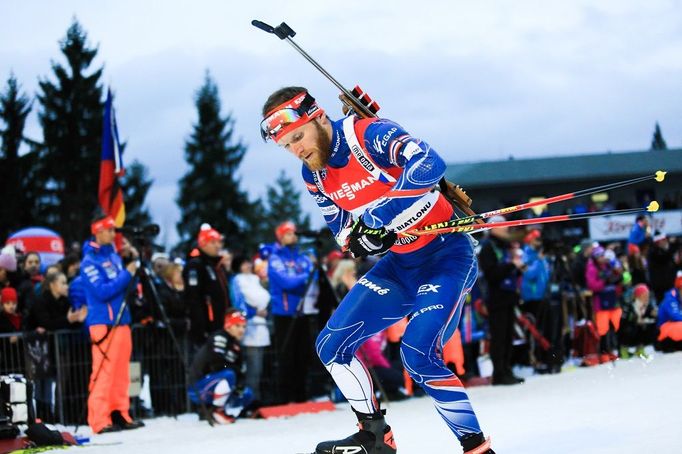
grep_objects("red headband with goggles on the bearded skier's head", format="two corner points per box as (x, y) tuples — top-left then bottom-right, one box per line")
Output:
(261, 91), (324, 142)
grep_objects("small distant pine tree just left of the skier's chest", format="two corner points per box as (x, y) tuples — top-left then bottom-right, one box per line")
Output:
(264, 170), (310, 241)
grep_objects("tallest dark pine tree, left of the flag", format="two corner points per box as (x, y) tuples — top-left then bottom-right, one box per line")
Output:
(33, 19), (104, 242)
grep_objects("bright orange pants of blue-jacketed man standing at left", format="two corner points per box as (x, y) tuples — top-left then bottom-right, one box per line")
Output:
(88, 325), (133, 433)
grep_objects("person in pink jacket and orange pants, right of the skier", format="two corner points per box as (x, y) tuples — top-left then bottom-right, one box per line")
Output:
(585, 246), (623, 362)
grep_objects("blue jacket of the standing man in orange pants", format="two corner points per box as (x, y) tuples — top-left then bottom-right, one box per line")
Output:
(80, 241), (132, 326)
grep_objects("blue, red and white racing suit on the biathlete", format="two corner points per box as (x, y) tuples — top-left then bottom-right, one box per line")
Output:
(303, 117), (481, 438)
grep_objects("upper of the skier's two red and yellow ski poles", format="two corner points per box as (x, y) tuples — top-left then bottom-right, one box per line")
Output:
(420, 170), (667, 230)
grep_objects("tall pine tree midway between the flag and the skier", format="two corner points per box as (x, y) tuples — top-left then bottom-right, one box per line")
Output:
(176, 72), (257, 254)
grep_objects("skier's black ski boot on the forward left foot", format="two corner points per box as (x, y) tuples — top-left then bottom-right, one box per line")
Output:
(315, 410), (398, 454)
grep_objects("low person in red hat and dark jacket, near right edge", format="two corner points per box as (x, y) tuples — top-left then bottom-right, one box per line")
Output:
(620, 284), (657, 359)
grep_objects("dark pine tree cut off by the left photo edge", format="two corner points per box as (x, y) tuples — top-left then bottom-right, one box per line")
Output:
(0, 74), (37, 240)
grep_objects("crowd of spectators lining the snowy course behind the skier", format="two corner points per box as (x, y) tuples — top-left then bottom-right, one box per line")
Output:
(0, 216), (682, 432)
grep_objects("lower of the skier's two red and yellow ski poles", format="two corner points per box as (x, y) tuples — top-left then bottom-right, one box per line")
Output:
(407, 200), (659, 236)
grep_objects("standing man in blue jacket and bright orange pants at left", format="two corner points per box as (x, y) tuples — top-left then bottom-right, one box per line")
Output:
(80, 216), (144, 433)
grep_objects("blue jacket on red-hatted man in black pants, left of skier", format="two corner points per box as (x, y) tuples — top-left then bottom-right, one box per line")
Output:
(268, 244), (313, 316)
